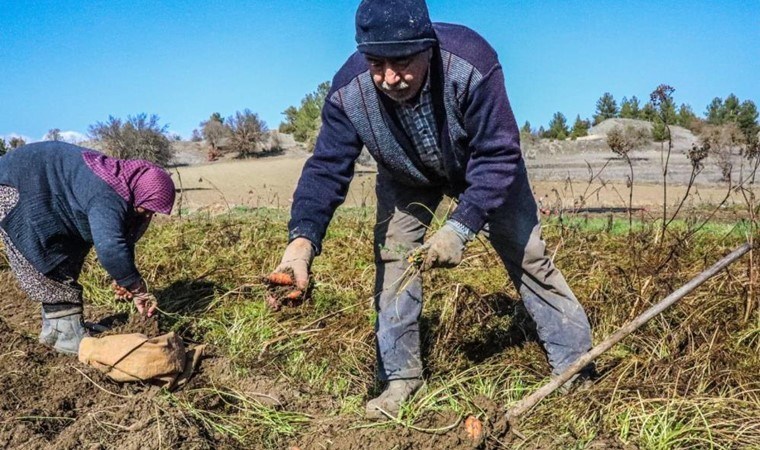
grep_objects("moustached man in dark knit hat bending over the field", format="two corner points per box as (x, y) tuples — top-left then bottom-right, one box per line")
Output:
(276, 0), (591, 418)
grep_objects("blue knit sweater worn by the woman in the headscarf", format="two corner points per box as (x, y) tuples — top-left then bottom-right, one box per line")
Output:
(0, 142), (141, 286)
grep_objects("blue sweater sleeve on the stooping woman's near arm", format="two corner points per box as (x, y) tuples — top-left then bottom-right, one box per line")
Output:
(87, 201), (142, 286)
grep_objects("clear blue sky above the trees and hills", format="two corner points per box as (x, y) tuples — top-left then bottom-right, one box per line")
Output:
(0, 0), (760, 140)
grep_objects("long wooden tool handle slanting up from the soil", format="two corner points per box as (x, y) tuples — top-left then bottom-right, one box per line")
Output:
(507, 243), (752, 427)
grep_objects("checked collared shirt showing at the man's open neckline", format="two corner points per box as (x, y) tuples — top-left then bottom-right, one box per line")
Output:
(396, 73), (446, 177)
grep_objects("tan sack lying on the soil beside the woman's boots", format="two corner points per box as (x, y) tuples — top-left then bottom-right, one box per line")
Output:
(79, 332), (192, 385)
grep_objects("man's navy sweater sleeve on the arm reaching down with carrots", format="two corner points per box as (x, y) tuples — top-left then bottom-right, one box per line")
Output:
(288, 97), (362, 254)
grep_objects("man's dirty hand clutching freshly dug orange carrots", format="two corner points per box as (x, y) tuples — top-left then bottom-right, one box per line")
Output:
(265, 238), (314, 310)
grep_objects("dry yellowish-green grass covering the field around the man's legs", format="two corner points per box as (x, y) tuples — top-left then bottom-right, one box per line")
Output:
(72, 209), (760, 449)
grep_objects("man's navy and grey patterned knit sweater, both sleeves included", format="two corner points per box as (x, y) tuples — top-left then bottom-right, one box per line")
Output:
(288, 23), (524, 252)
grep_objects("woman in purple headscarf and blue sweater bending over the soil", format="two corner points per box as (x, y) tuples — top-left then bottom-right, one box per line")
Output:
(0, 142), (174, 355)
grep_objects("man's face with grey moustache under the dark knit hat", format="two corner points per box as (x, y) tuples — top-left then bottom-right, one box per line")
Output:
(365, 50), (432, 102)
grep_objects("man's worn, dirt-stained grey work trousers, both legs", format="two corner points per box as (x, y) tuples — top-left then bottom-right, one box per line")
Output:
(375, 163), (591, 380)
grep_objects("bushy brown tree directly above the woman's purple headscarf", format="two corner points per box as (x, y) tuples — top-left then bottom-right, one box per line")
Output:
(89, 113), (174, 166)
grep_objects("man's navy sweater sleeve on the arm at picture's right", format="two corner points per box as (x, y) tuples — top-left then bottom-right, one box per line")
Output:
(451, 64), (522, 232)
